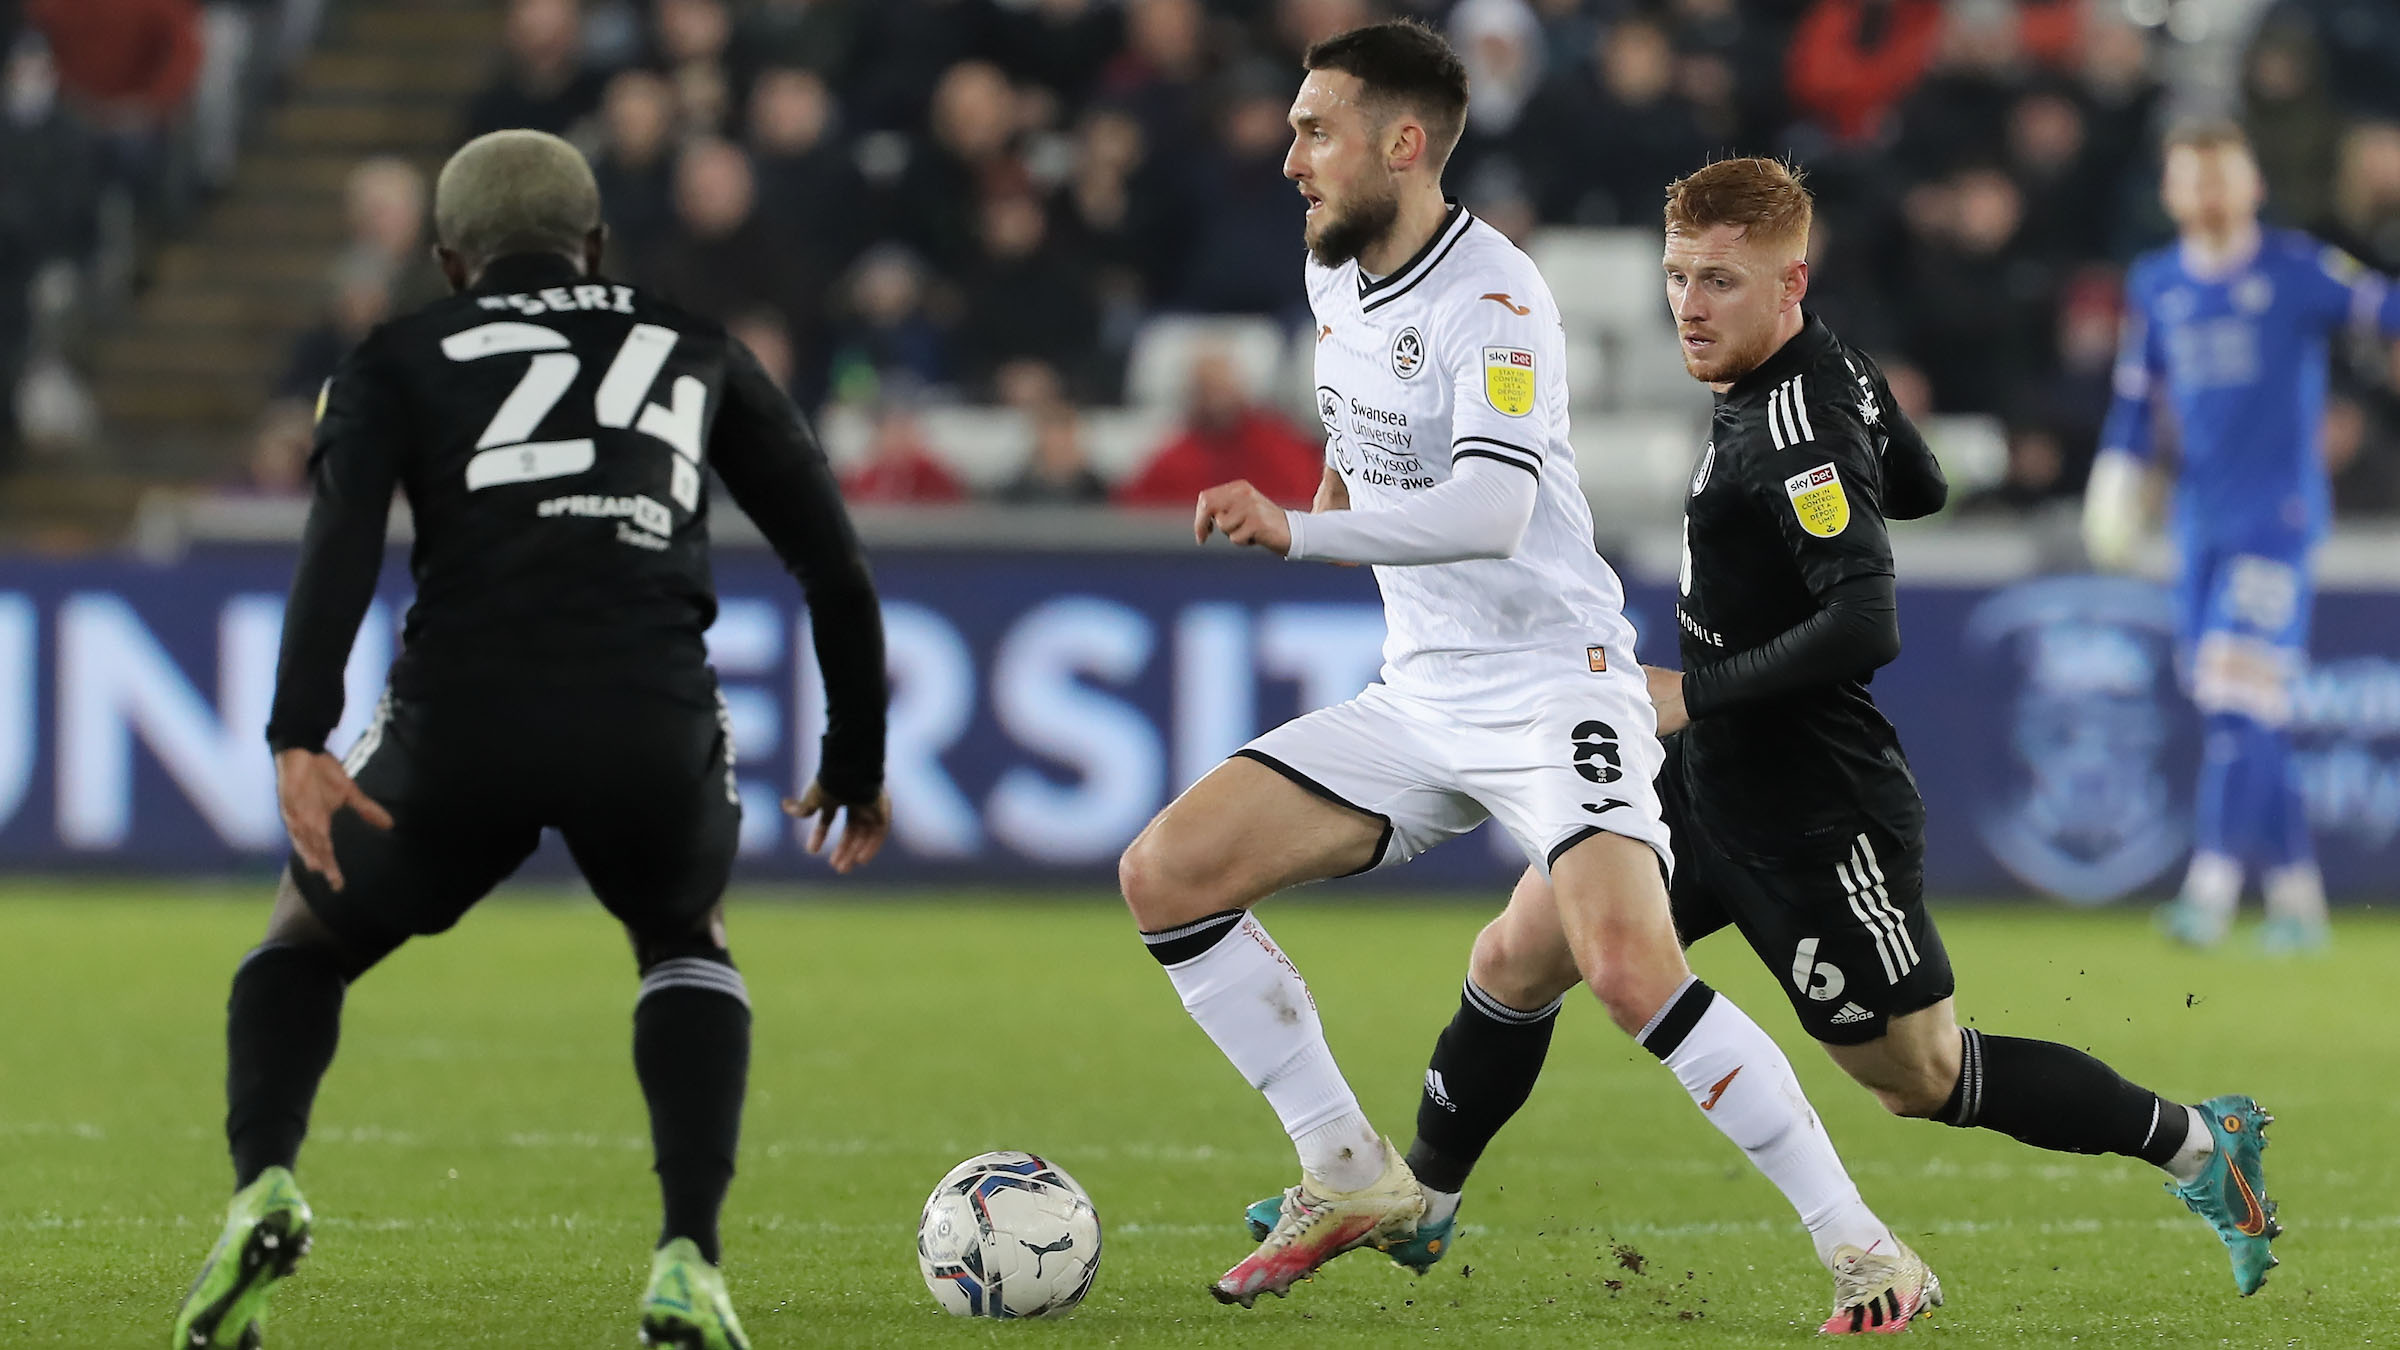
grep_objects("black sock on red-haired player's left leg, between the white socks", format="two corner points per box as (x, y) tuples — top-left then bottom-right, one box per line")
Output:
(1409, 980), (1558, 1191)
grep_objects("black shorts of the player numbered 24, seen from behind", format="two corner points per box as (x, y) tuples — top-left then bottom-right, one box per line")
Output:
(290, 694), (742, 958)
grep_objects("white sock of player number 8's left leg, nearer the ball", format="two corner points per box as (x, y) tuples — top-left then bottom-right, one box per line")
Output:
(1142, 915), (1385, 1191)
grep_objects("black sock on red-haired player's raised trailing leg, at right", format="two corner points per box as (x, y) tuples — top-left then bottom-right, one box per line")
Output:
(1934, 1031), (2191, 1167)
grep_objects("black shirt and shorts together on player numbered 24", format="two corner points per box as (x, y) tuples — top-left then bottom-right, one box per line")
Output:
(269, 255), (886, 951)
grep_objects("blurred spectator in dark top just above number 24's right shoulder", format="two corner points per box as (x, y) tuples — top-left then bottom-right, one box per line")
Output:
(641, 139), (821, 374)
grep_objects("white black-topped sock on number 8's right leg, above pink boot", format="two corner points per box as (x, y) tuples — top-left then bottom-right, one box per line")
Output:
(1637, 978), (1891, 1266)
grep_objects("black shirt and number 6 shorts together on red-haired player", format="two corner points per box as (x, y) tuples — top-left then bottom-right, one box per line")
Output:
(1658, 317), (1951, 1043)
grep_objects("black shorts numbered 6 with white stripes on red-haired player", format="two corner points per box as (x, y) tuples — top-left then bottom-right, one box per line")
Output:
(1658, 740), (1956, 1045)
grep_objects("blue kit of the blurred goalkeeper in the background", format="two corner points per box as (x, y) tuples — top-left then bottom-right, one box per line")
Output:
(2100, 228), (2400, 870)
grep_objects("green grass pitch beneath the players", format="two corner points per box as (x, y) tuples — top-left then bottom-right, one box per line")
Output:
(0, 884), (2400, 1350)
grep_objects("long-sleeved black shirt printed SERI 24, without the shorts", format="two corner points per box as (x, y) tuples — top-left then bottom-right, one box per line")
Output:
(266, 255), (888, 802)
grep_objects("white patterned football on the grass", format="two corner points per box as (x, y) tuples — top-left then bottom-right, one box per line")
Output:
(917, 1151), (1099, 1319)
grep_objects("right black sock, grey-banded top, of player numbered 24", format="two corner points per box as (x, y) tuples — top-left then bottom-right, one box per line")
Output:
(634, 951), (749, 1266)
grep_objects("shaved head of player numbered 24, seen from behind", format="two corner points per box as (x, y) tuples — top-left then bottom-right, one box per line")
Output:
(434, 130), (600, 276)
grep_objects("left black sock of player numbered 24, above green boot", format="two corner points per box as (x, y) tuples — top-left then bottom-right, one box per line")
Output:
(226, 944), (348, 1189)
